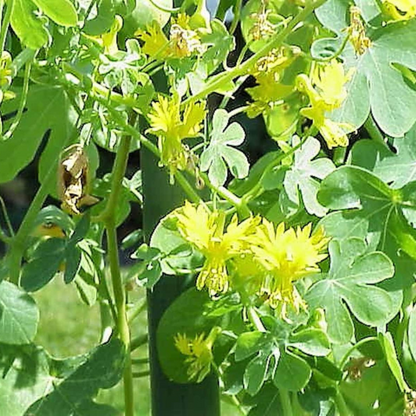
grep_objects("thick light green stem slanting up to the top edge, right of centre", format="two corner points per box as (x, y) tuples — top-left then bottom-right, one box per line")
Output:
(182, 0), (326, 106)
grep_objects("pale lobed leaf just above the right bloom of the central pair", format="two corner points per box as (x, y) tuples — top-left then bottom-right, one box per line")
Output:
(276, 137), (335, 217)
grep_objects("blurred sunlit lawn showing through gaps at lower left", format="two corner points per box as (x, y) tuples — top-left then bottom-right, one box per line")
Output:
(35, 276), (239, 416)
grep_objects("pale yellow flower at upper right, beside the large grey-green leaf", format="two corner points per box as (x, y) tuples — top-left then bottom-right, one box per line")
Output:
(296, 60), (354, 148)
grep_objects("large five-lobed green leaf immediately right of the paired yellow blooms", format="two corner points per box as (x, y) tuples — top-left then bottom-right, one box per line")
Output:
(306, 238), (394, 343)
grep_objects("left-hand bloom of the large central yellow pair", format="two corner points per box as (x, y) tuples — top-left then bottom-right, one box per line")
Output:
(176, 202), (259, 296)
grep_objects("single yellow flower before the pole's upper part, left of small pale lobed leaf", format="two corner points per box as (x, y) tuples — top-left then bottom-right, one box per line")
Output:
(148, 95), (205, 175)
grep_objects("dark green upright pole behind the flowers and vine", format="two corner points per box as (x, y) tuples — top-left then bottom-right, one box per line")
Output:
(138, 148), (220, 416)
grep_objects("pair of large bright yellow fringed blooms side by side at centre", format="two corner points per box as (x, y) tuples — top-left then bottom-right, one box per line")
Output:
(175, 202), (328, 317)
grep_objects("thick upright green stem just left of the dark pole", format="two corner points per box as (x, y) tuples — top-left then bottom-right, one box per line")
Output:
(103, 136), (134, 416)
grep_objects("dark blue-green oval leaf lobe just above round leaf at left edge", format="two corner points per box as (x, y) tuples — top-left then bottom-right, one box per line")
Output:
(20, 238), (65, 292)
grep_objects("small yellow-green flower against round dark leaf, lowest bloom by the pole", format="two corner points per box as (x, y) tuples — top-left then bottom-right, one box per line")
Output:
(174, 327), (221, 383)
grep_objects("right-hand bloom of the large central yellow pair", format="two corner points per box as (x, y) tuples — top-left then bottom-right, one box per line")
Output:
(252, 219), (328, 318)
